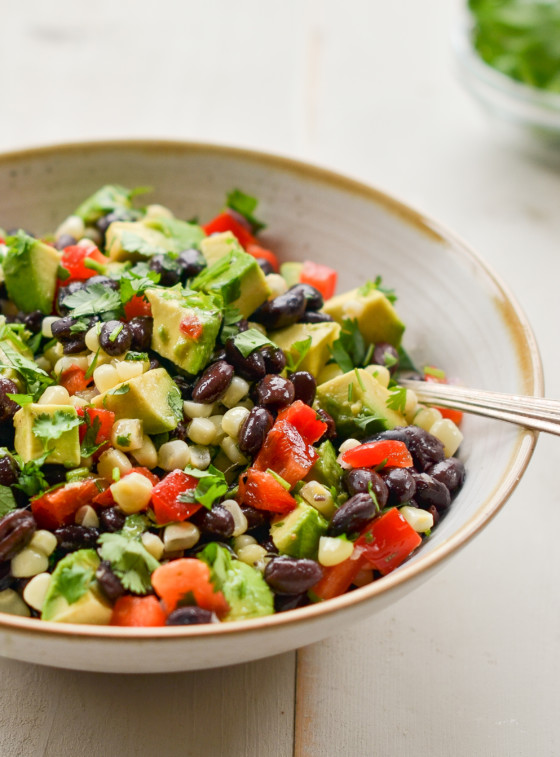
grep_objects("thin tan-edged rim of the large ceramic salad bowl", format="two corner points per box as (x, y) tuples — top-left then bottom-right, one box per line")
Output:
(0, 138), (543, 642)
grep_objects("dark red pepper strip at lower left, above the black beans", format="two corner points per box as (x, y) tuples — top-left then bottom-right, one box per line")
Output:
(31, 478), (104, 531)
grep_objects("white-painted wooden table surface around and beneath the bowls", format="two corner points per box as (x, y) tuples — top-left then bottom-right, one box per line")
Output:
(0, 0), (560, 757)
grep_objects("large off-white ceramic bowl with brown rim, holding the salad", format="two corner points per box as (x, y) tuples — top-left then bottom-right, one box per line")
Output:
(0, 141), (542, 673)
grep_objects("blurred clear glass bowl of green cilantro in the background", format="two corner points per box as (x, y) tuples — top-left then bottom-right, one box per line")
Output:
(454, 0), (560, 143)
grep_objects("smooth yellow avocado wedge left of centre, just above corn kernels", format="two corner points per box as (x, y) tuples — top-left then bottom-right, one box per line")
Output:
(92, 368), (179, 434)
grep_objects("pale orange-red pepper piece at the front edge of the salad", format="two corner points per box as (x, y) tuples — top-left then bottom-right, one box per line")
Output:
(152, 557), (229, 618)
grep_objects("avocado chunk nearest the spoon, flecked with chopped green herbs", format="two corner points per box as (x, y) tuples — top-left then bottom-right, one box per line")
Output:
(316, 368), (406, 439)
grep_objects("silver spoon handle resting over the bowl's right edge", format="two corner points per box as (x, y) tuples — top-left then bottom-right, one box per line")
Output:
(399, 379), (560, 436)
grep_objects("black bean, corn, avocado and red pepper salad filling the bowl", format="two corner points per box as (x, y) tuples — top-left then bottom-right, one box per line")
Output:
(0, 185), (465, 626)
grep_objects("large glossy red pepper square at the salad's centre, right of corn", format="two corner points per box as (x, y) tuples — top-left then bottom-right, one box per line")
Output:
(253, 420), (319, 486)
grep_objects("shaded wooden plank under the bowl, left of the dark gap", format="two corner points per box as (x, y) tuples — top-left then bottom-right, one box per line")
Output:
(0, 653), (295, 757)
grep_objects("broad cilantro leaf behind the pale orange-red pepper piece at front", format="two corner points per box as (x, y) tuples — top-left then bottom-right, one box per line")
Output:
(98, 533), (159, 594)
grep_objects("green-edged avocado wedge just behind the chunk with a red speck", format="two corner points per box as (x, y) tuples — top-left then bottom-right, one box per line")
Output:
(191, 243), (270, 318)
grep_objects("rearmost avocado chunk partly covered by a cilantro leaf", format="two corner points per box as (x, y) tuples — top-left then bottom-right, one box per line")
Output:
(106, 216), (204, 261)
